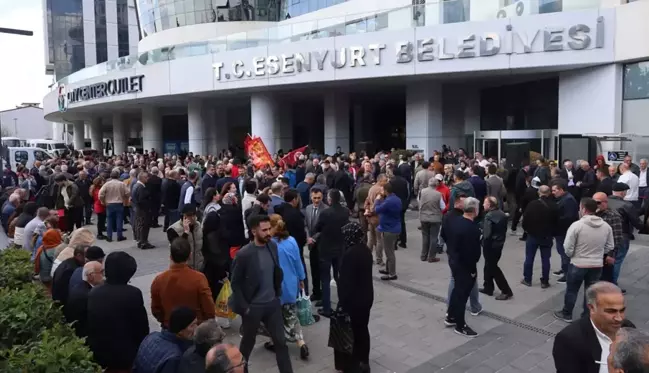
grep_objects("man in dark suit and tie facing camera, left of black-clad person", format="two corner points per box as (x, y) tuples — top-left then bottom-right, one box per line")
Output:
(305, 187), (328, 300)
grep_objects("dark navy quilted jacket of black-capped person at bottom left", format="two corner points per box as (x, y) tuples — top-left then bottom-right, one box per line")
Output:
(133, 330), (191, 373)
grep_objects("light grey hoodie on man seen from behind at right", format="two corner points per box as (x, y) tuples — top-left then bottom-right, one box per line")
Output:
(563, 215), (614, 268)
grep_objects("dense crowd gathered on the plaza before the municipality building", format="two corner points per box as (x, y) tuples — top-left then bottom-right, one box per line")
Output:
(0, 148), (649, 373)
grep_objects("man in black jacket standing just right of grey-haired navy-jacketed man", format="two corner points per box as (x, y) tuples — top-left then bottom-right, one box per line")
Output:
(480, 196), (514, 300)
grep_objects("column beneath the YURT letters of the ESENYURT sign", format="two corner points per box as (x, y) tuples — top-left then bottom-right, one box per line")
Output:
(324, 91), (349, 154)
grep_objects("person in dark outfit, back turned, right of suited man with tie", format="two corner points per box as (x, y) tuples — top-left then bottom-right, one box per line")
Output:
(315, 188), (349, 317)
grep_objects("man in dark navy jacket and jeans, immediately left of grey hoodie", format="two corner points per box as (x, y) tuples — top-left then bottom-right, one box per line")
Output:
(552, 180), (579, 284)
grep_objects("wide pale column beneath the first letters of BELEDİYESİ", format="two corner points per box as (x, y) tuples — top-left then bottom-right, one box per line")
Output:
(406, 82), (444, 158)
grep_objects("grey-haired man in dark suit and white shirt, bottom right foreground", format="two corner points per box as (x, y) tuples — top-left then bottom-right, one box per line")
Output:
(552, 281), (634, 373)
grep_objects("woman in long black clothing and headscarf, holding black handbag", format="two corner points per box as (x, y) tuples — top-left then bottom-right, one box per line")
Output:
(334, 222), (374, 373)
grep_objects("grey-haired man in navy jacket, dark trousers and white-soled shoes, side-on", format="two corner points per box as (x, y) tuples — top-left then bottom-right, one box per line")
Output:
(442, 197), (480, 338)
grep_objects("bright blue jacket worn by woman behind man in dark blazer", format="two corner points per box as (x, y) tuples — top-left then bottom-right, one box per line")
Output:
(273, 237), (306, 304)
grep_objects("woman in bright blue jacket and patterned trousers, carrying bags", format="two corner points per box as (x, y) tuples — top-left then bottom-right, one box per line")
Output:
(264, 214), (309, 360)
